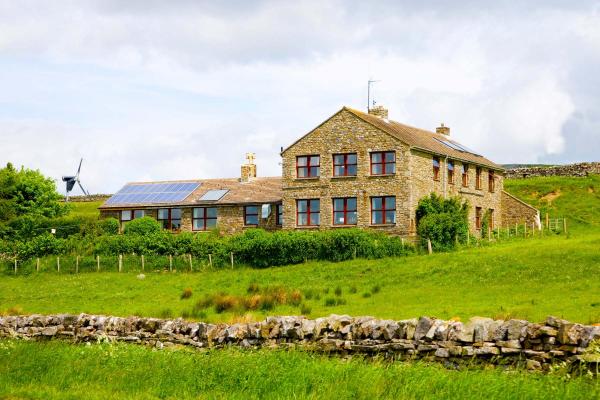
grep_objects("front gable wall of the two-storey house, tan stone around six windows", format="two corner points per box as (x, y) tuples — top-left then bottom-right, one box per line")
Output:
(282, 111), (411, 235)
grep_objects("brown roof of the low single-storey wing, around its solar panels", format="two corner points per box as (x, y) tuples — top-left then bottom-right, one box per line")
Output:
(99, 177), (283, 209)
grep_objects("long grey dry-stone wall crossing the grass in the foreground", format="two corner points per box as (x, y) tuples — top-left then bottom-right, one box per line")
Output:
(0, 314), (600, 370)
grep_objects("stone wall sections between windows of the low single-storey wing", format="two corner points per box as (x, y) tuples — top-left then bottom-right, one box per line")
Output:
(100, 203), (279, 234)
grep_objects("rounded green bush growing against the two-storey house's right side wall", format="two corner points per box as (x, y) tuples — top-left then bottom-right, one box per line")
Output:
(416, 193), (469, 251)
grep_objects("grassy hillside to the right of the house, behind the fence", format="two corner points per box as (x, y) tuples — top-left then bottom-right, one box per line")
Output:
(504, 175), (600, 230)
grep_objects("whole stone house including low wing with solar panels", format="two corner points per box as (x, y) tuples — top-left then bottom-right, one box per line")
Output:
(100, 106), (539, 235)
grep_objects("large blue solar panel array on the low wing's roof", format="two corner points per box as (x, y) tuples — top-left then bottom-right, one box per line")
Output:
(106, 182), (200, 204)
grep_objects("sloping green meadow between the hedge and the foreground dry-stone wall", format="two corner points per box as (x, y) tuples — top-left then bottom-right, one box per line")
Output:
(0, 232), (600, 323)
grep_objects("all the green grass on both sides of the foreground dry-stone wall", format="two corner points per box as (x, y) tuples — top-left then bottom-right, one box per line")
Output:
(0, 176), (600, 399)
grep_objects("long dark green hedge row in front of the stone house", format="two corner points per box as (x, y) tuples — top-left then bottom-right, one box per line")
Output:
(0, 229), (413, 268)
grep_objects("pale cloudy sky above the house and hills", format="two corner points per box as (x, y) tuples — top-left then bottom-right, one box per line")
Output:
(0, 0), (600, 194)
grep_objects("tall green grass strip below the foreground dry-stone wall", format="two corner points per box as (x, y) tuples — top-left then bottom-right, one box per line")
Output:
(0, 341), (600, 399)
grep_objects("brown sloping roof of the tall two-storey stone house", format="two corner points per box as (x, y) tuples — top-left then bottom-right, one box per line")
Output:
(283, 107), (504, 171)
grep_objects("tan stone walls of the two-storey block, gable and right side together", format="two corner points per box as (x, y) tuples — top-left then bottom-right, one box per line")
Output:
(282, 110), (503, 235)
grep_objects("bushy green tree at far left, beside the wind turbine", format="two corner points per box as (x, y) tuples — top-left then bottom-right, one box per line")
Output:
(0, 163), (69, 222)
